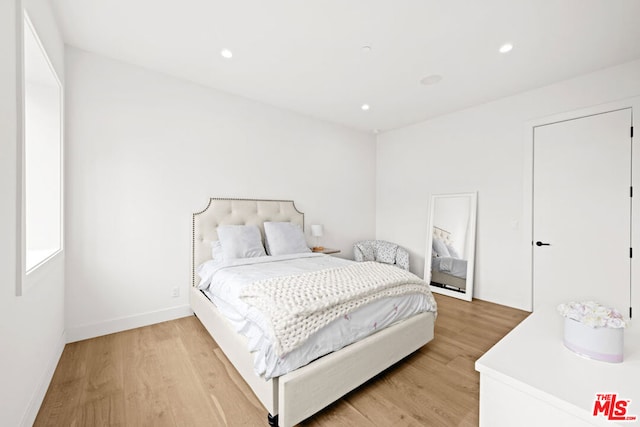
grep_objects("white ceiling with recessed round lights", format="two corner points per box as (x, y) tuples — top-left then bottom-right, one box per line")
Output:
(51, 0), (640, 131)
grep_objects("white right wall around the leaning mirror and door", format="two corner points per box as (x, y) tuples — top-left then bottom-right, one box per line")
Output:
(376, 61), (640, 309)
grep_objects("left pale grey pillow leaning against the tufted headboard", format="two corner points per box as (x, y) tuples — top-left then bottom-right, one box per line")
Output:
(217, 225), (266, 261)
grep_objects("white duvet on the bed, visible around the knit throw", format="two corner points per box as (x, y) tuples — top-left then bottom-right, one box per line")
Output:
(198, 253), (435, 379)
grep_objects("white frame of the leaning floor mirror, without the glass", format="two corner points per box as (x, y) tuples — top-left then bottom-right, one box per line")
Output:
(424, 191), (478, 301)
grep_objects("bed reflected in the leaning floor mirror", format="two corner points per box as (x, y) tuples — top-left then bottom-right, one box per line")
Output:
(431, 226), (467, 292)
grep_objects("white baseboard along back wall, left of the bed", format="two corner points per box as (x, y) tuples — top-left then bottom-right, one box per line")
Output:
(67, 304), (193, 343)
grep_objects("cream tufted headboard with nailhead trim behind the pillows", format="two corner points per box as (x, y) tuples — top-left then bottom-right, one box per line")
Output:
(191, 198), (304, 286)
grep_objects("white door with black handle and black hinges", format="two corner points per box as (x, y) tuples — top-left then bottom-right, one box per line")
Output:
(532, 108), (632, 317)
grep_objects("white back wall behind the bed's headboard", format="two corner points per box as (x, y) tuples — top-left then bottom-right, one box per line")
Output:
(65, 48), (376, 340)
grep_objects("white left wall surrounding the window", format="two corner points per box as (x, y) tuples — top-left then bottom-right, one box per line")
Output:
(0, 0), (65, 426)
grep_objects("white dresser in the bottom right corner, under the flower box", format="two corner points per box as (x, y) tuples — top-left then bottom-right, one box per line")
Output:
(476, 307), (640, 427)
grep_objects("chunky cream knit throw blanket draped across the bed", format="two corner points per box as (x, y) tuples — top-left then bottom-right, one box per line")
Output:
(240, 261), (436, 356)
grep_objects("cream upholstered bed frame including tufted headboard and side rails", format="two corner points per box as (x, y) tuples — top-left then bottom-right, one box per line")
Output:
(190, 198), (435, 427)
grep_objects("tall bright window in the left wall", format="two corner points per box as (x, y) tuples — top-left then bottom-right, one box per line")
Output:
(22, 12), (62, 290)
